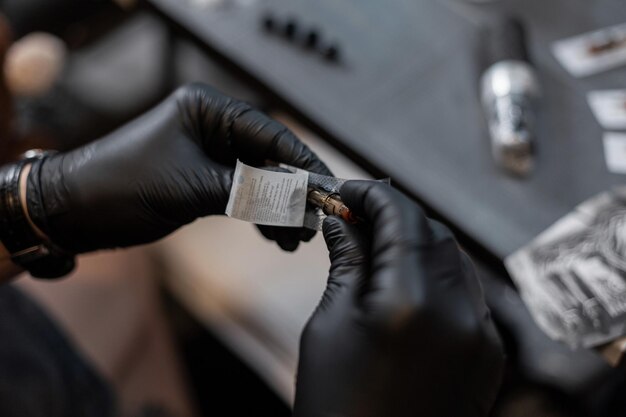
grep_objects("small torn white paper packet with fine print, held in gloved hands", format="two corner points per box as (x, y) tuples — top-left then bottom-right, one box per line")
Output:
(226, 161), (309, 227)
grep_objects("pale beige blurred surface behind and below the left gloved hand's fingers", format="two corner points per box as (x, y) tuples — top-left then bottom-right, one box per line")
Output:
(158, 114), (368, 402)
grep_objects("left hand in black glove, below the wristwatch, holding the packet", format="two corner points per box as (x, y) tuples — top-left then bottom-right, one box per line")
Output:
(27, 84), (331, 253)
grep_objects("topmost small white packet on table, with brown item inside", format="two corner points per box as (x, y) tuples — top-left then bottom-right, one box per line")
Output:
(552, 23), (626, 77)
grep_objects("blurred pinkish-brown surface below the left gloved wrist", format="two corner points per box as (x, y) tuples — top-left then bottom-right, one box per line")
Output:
(17, 248), (196, 417)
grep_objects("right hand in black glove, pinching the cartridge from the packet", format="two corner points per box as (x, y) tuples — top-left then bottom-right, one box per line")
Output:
(294, 181), (503, 417)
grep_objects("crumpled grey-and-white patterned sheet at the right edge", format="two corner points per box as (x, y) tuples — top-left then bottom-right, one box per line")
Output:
(505, 191), (626, 347)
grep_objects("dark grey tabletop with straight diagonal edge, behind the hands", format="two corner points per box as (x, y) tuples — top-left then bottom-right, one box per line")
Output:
(146, 0), (626, 258)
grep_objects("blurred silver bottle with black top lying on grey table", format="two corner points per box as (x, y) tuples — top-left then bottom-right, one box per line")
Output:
(481, 18), (541, 176)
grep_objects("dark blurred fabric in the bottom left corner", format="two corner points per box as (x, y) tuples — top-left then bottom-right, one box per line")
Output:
(0, 285), (115, 417)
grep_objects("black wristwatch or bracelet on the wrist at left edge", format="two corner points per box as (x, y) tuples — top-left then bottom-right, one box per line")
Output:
(0, 155), (75, 278)
